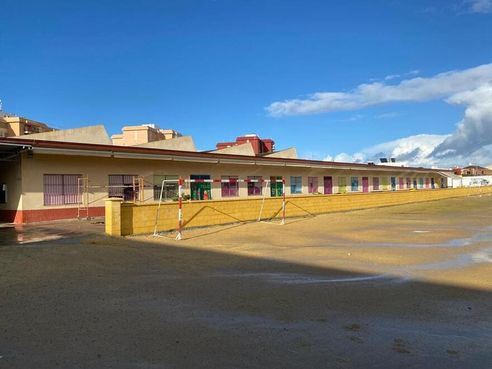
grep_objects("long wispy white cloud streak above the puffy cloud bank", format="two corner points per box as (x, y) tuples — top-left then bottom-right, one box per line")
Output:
(266, 64), (492, 116)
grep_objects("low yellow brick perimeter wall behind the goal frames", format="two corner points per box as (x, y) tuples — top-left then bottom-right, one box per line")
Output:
(106, 186), (492, 236)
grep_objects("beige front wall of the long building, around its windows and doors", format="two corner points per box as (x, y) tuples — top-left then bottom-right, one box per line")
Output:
(20, 153), (446, 210)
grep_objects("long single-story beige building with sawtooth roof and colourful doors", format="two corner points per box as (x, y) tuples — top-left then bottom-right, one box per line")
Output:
(0, 113), (452, 223)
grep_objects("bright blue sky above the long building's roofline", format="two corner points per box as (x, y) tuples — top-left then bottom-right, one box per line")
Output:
(0, 0), (492, 165)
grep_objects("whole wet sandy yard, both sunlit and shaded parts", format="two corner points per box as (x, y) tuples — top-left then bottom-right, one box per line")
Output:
(0, 196), (492, 369)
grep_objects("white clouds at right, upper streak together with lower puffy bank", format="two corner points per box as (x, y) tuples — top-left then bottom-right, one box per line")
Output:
(268, 64), (492, 166)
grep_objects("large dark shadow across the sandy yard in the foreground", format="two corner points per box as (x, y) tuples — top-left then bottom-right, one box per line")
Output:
(0, 224), (492, 369)
